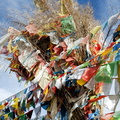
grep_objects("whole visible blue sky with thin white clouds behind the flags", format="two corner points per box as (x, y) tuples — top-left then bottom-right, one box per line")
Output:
(0, 0), (120, 115)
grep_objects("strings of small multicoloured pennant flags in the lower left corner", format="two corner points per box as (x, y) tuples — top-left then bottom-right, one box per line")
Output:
(0, 84), (40, 120)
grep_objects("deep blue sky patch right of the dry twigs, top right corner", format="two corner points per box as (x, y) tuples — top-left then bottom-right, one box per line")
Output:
(78, 0), (120, 22)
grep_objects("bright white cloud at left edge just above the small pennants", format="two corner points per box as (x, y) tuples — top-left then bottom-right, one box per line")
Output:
(0, 88), (13, 101)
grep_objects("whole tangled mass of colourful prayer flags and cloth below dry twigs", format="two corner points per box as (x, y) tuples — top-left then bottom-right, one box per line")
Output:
(0, 0), (120, 120)
